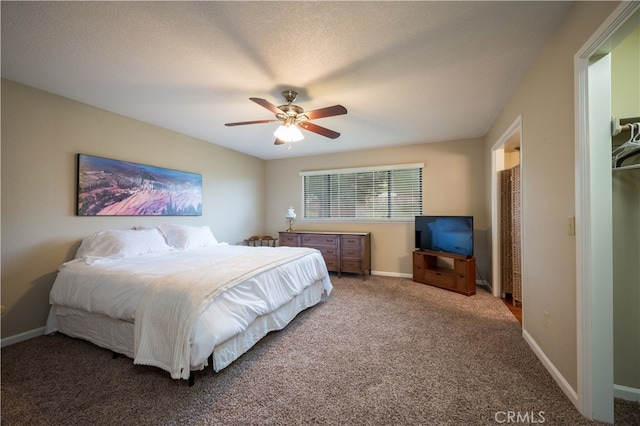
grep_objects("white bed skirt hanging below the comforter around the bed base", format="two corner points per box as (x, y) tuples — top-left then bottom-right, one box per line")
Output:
(45, 281), (323, 371)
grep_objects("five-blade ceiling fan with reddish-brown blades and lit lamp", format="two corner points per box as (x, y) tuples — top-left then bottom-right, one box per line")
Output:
(225, 90), (347, 145)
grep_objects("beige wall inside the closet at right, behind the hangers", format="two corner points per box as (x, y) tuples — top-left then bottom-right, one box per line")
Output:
(611, 28), (640, 389)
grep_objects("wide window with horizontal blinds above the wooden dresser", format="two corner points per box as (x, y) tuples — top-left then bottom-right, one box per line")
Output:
(300, 164), (424, 221)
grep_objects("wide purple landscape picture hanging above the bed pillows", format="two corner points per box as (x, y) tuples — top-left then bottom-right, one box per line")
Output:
(76, 154), (202, 216)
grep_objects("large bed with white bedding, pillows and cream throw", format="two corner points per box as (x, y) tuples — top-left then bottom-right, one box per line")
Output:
(45, 225), (332, 385)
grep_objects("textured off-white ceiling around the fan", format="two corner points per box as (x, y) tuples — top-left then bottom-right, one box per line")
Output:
(1, 1), (570, 159)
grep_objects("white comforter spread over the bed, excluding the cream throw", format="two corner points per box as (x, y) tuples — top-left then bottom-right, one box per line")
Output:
(47, 245), (332, 376)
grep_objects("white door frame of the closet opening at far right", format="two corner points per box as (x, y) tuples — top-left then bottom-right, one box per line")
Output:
(574, 1), (640, 423)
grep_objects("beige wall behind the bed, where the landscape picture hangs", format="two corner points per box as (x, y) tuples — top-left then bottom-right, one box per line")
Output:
(2, 80), (265, 338)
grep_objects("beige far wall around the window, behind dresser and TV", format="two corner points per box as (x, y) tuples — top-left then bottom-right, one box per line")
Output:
(266, 140), (488, 276)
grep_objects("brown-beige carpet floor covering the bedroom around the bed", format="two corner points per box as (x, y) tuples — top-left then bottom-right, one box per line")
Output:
(1, 276), (640, 425)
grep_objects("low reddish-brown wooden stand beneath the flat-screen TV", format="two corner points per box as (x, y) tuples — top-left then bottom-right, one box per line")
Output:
(413, 250), (476, 296)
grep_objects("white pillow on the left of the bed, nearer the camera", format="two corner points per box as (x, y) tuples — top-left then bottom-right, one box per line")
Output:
(76, 228), (171, 260)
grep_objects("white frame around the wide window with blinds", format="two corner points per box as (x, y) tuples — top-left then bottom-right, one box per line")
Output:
(300, 163), (424, 222)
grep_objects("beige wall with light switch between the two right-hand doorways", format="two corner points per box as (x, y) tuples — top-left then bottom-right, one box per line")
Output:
(485, 2), (618, 390)
